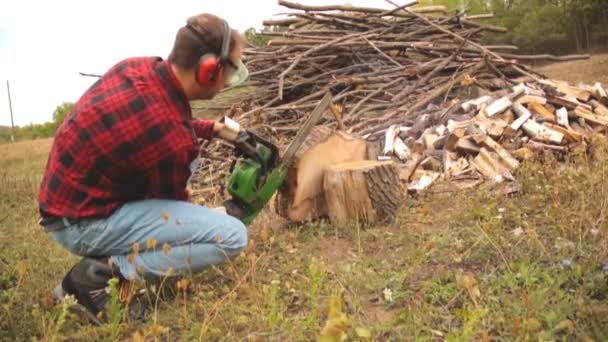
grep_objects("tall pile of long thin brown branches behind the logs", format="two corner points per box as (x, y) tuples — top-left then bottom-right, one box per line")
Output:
(189, 0), (588, 206)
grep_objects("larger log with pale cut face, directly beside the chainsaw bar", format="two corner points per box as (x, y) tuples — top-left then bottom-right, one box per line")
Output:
(278, 126), (367, 222)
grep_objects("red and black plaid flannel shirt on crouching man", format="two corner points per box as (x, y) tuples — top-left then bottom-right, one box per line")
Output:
(38, 57), (214, 219)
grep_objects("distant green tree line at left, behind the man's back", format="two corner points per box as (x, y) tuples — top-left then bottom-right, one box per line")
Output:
(0, 102), (74, 143)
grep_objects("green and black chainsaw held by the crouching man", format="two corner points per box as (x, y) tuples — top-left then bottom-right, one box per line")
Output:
(222, 93), (332, 225)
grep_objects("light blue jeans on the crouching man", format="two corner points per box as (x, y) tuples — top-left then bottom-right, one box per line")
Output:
(53, 199), (247, 279)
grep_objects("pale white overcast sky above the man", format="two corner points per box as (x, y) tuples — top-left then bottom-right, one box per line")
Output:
(0, 0), (394, 126)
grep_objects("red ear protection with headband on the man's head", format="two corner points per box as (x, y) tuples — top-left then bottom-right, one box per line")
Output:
(186, 20), (230, 87)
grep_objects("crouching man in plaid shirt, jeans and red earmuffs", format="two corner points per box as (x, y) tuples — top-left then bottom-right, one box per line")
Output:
(38, 14), (247, 323)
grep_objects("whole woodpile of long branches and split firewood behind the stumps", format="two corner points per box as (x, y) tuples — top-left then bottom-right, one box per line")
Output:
(195, 0), (608, 223)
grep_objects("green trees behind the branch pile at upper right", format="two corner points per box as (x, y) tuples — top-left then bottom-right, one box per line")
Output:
(420, 0), (608, 54)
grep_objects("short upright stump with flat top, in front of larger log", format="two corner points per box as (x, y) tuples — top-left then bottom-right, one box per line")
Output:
(323, 160), (404, 224)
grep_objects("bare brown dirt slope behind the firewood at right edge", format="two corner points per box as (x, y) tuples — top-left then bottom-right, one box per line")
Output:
(536, 53), (608, 85)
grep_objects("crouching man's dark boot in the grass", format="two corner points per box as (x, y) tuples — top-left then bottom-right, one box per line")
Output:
(55, 257), (124, 325)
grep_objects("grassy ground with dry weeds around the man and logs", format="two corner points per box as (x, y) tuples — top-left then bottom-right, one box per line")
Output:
(0, 59), (608, 341)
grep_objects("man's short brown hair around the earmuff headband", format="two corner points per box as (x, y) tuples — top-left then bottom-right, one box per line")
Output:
(169, 13), (244, 70)
